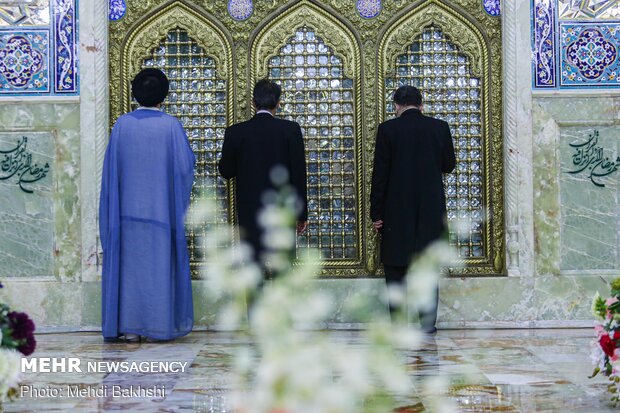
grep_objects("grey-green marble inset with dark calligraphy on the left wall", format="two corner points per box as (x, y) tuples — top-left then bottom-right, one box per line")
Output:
(0, 132), (56, 277)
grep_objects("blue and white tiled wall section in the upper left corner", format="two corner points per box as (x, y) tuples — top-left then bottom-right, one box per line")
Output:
(0, 0), (79, 96)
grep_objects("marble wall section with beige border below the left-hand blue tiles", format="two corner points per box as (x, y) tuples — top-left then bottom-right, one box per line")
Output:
(0, 101), (81, 280)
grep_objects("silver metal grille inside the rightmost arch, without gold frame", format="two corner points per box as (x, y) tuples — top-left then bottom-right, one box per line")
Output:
(386, 27), (485, 258)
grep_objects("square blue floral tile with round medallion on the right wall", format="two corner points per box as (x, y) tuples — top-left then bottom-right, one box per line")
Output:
(560, 22), (620, 86)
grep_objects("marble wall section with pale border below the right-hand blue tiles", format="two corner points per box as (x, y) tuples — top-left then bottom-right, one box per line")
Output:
(533, 96), (620, 275)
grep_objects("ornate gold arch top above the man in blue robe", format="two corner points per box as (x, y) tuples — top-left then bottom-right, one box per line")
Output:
(110, 1), (234, 124)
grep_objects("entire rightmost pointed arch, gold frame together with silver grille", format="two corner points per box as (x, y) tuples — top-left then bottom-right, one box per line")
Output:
(377, 0), (504, 275)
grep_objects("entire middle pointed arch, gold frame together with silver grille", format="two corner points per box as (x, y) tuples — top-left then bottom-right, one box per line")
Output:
(248, 1), (367, 276)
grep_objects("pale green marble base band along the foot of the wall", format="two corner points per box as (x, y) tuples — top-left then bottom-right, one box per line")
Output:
(24, 275), (613, 331)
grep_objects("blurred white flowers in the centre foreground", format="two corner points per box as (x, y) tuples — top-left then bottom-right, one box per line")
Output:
(192, 181), (462, 413)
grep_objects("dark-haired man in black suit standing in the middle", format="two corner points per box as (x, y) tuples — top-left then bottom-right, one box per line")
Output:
(218, 79), (308, 274)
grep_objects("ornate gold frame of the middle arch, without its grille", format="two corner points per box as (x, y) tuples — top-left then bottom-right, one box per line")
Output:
(248, 0), (373, 277)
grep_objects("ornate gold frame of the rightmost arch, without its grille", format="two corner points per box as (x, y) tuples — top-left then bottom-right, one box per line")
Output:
(377, 0), (505, 275)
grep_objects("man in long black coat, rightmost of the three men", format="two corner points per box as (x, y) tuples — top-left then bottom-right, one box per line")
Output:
(370, 86), (456, 333)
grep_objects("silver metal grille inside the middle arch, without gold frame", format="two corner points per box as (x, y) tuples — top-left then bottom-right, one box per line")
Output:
(269, 26), (359, 260)
